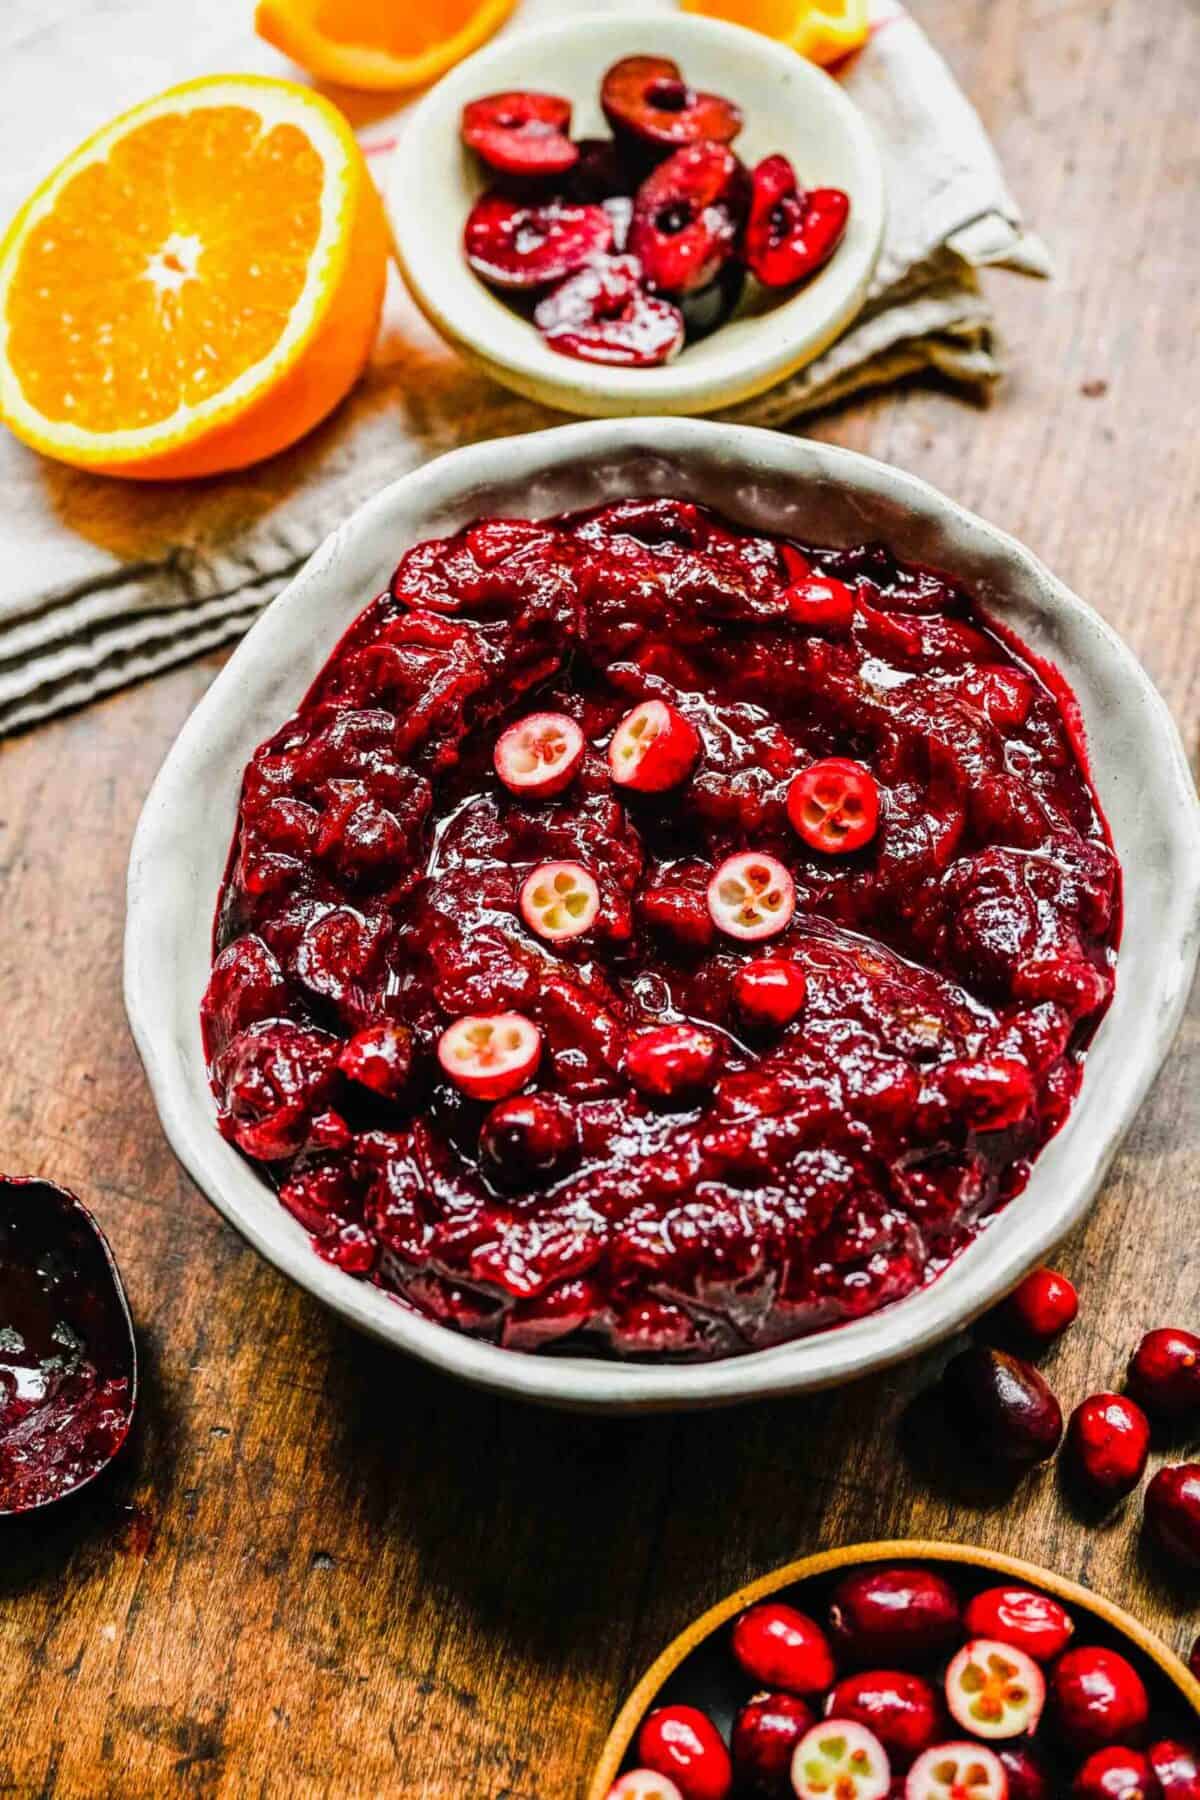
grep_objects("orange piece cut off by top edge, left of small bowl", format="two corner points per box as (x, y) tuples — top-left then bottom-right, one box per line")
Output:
(254, 0), (516, 88)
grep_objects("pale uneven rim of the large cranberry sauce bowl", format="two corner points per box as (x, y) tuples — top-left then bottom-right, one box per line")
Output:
(124, 418), (1200, 1411)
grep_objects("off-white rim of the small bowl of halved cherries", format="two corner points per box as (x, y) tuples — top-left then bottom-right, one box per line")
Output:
(383, 11), (887, 416)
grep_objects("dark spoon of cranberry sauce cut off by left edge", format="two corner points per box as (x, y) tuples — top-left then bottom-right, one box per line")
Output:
(0, 1177), (135, 1514)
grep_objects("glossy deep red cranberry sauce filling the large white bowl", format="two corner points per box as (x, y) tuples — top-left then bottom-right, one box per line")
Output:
(203, 500), (1119, 1357)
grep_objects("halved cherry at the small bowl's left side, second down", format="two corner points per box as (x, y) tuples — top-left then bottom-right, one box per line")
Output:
(462, 193), (612, 293)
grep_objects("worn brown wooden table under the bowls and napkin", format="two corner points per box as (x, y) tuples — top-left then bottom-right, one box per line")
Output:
(0, 0), (1200, 1800)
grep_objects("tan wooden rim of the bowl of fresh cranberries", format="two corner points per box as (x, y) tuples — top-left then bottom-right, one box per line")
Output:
(587, 1537), (1200, 1800)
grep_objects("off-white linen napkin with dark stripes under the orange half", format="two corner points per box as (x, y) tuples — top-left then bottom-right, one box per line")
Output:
(0, 0), (1049, 734)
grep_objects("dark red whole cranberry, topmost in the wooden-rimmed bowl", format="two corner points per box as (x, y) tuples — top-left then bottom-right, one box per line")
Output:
(829, 1566), (963, 1669)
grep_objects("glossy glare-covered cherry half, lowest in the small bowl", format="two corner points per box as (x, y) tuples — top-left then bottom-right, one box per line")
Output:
(533, 256), (684, 369)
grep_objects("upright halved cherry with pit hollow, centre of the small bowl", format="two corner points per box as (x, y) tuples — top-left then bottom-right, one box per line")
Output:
(630, 142), (745, 299)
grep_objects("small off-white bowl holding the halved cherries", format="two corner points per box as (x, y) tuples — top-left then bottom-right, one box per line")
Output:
(385, 13), (883, 416)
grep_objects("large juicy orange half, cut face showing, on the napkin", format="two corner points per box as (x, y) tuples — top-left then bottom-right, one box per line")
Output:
(0, 76), (389, 479)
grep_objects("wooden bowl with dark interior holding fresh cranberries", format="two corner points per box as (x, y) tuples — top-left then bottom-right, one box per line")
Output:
(587, 1537), (1200, 1800)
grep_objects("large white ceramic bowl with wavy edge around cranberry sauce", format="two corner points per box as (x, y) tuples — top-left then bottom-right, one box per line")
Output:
(126, 419), (1200, 1411)
